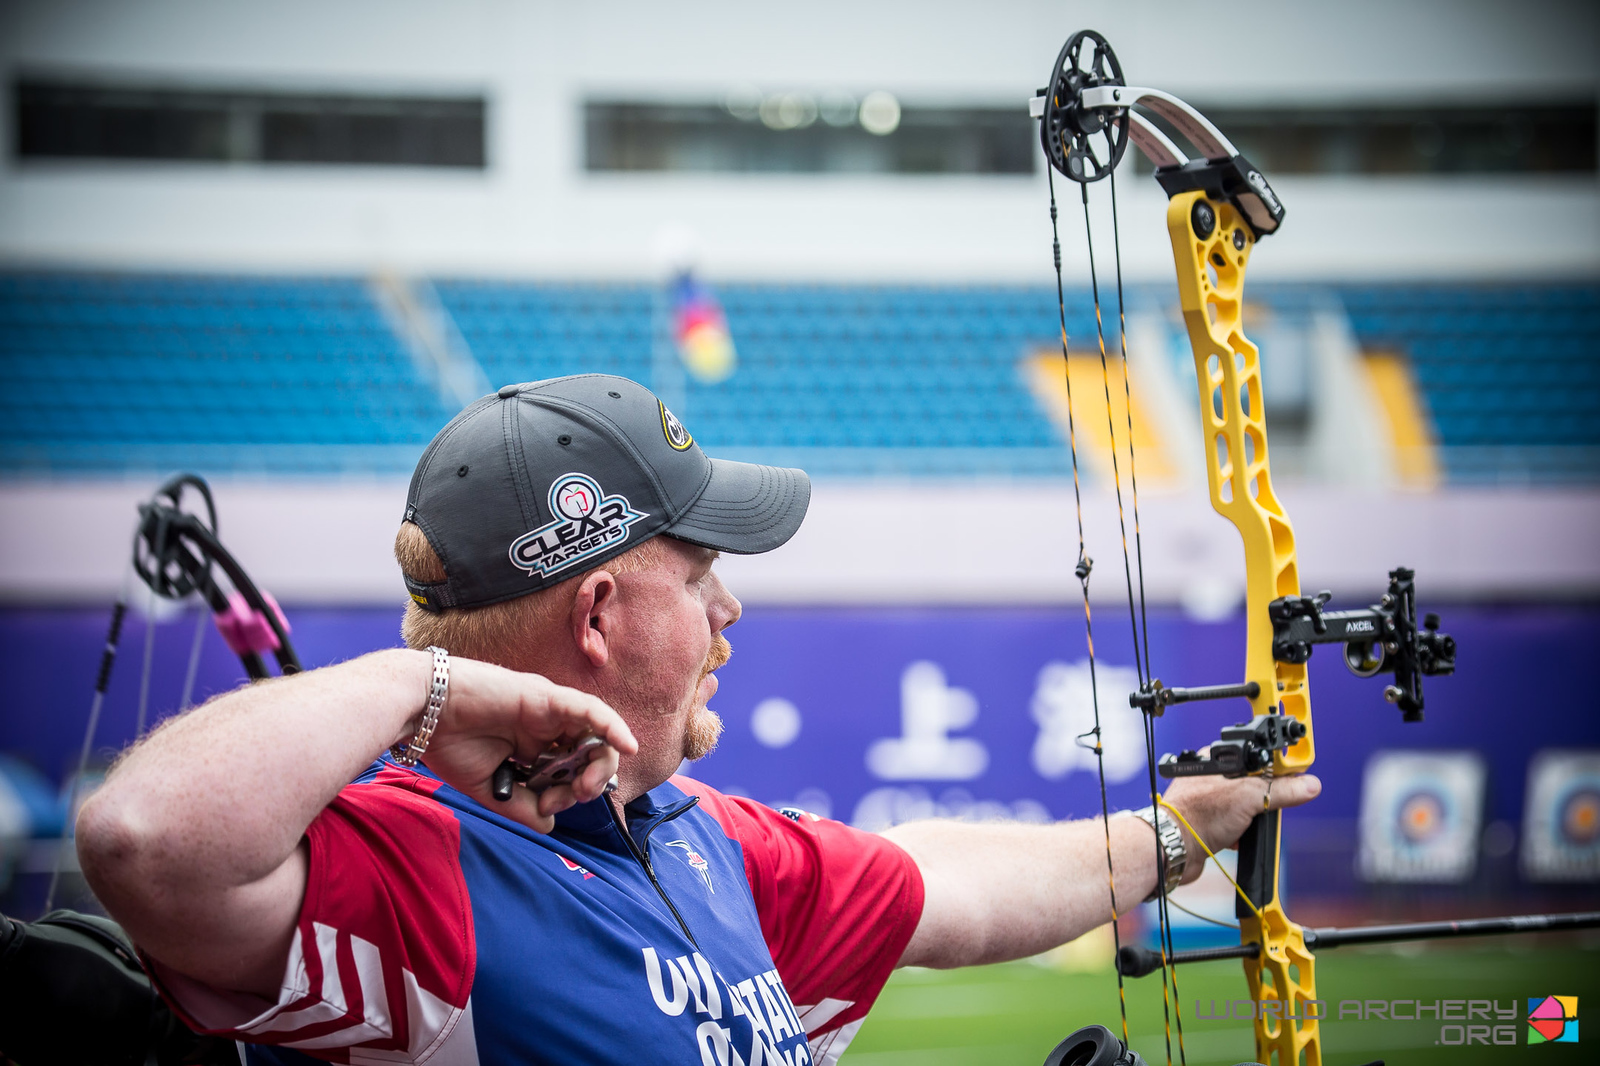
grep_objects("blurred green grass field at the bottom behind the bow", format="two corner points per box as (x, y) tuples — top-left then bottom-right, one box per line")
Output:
(843, 938), (1600, 1066)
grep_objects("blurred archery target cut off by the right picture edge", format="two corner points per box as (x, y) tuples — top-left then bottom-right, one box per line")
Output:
(1522, 751), (1600, 882)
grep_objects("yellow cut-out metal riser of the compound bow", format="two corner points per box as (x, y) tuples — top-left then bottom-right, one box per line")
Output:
(1166, 189), (1322, 1066)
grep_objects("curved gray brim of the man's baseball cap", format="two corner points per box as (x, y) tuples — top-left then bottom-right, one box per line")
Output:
(662, 459), (811, 555)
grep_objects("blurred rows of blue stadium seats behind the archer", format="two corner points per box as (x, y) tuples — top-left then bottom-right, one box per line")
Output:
(0, 272), (1600, 480)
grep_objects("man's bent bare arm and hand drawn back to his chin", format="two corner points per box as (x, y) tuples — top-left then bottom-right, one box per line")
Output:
(77, 650), (637, 999)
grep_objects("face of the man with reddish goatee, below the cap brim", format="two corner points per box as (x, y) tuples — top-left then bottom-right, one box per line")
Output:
(602, 536), (741, 789)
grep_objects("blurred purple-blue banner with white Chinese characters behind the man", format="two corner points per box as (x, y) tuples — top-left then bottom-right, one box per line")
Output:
(0, 607), (1600, 887)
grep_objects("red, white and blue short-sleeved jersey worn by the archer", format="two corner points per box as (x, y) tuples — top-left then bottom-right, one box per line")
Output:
(152, 762), (923, 1066)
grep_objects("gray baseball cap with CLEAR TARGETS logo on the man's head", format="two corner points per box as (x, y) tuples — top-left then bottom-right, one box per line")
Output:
(405, 375), (811, 611)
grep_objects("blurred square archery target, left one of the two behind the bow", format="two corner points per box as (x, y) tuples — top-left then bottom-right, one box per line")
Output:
(1360, 751), (1485, 884)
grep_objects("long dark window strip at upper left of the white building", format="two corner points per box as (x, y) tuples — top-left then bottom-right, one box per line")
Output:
(13, 78), (485, 168)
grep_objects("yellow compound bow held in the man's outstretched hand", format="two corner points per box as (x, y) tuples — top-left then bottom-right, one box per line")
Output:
(1030, 30), (1600, 1066)
